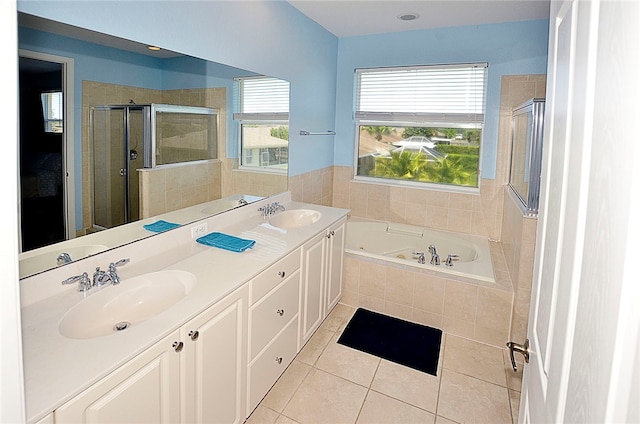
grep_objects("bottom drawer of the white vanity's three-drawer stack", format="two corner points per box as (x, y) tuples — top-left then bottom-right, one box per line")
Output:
(247, 318), (298, 413)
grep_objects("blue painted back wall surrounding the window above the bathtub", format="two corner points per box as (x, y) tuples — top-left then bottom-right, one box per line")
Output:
(334, 20), (549, 179)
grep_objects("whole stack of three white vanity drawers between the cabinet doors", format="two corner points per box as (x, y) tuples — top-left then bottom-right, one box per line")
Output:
(247, 249), (300, 416)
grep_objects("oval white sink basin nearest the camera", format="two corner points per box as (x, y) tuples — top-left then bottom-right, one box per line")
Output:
(58, 270), (196, 339)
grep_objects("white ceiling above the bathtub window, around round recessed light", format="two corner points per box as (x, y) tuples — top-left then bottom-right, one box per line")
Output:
(288, 0), (549, 38)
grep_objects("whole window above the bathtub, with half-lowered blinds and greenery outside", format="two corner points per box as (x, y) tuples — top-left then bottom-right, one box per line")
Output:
(355, 63), (487, 191)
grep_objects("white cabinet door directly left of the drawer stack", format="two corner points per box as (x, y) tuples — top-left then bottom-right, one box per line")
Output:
(181, 286), (248, 423)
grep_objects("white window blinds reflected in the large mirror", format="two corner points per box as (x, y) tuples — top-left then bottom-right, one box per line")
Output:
(234, 77), (289, 120)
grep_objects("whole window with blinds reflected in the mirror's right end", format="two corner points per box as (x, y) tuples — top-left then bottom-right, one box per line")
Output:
(234, 77), (289, 173)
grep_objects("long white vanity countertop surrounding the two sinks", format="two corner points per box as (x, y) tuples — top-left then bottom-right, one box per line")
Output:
(22, 198), (348, 423)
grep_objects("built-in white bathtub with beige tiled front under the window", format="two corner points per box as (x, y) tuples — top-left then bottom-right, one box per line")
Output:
(341, 217), (513, 348)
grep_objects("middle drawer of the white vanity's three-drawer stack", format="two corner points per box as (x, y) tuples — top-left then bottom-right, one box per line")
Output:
(248, 270), (300, 362)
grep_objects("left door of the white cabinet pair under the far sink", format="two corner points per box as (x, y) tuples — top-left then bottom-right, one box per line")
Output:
(300, 232), (326, 347)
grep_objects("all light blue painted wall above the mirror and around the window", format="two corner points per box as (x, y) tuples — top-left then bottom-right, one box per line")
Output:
(18, 0), (548, 184)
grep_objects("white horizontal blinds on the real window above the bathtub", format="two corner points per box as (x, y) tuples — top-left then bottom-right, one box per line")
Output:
(356, 63), (487, 122)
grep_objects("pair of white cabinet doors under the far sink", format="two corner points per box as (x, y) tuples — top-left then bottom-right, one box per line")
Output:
(299, 218), (346, 348)
